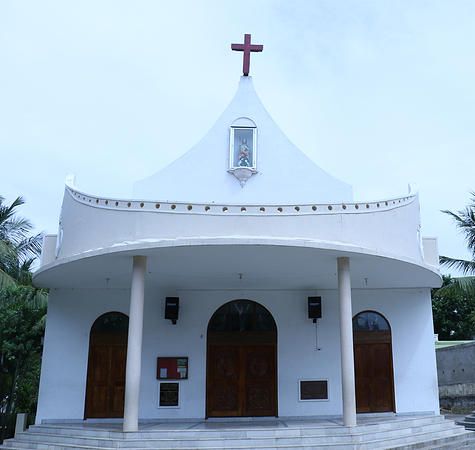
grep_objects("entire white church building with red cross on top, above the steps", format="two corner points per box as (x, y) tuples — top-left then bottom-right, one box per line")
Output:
(34, 37), (441, 431)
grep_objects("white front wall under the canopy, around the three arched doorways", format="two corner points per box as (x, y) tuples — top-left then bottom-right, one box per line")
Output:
(37, 289), (438, 422)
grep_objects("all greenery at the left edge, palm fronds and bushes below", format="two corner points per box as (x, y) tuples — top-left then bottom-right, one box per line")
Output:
(0, 196), (47, 434)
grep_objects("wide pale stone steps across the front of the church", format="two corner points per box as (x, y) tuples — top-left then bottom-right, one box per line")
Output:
(0, 416), (475, 450)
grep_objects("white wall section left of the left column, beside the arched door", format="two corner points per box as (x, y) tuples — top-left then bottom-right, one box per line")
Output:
(37, 289), (129, 419)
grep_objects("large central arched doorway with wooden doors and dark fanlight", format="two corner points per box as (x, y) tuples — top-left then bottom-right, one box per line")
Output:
(206, 300), (277, 417)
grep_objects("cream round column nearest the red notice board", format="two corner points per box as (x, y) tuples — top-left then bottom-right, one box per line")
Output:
(124, 256), (147, 431)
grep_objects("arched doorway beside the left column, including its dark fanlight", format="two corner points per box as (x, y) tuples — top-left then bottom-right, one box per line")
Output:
(84, 312), (129, 419)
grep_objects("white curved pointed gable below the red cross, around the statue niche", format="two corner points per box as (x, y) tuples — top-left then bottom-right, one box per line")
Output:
(134, 76), (352, 204)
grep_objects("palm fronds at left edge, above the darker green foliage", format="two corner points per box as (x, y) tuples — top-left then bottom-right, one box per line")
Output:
(0, 196), (41, 286)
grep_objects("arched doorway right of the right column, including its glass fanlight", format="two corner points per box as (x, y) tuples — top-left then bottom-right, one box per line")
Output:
(353, 311), (395, 413)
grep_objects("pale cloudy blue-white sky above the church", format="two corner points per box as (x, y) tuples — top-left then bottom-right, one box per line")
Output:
(0, 0), (475, 270)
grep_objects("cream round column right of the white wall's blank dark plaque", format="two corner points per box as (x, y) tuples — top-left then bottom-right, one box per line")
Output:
(337, 257), (356, 427)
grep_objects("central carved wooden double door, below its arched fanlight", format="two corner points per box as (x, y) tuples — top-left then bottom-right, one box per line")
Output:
(207, 343), (277, 417)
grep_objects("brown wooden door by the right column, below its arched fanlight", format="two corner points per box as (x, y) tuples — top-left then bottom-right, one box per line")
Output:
(354, 333), (394, 413)
